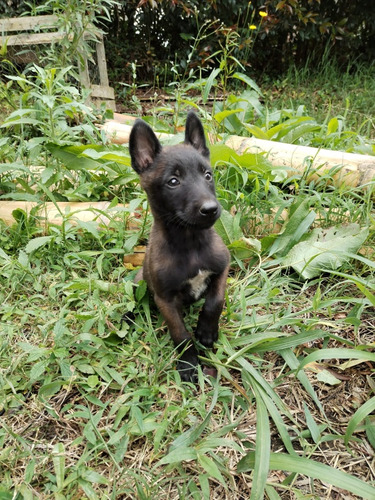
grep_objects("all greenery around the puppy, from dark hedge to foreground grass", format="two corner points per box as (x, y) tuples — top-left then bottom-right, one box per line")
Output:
(0, 0), (375, 500)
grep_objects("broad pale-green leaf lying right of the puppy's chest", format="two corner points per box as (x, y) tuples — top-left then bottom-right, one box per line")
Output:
(283, 224), (369, 279)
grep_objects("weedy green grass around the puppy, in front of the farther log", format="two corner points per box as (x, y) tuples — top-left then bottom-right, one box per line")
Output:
(0, 58), (375, 500)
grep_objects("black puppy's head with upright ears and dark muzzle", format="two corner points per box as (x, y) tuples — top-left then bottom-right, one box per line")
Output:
(129, 112), (221, 229)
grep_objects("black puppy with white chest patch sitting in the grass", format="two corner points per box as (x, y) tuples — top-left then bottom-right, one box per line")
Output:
(129, 111), (229, 381)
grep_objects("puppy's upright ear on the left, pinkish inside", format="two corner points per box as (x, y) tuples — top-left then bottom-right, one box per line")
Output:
(129, 120), (161, 174)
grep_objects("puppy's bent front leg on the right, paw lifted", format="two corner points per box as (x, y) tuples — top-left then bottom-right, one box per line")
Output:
(195, 267), (228, 347)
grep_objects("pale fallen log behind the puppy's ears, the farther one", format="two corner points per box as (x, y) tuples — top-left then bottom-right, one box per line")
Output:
(101, 117), (375, 187)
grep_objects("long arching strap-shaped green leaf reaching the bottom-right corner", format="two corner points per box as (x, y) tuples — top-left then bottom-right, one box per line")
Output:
(237, 451), (375, 500)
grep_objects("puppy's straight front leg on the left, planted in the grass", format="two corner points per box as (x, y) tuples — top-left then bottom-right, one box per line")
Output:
(154, 295), (198, 382)
